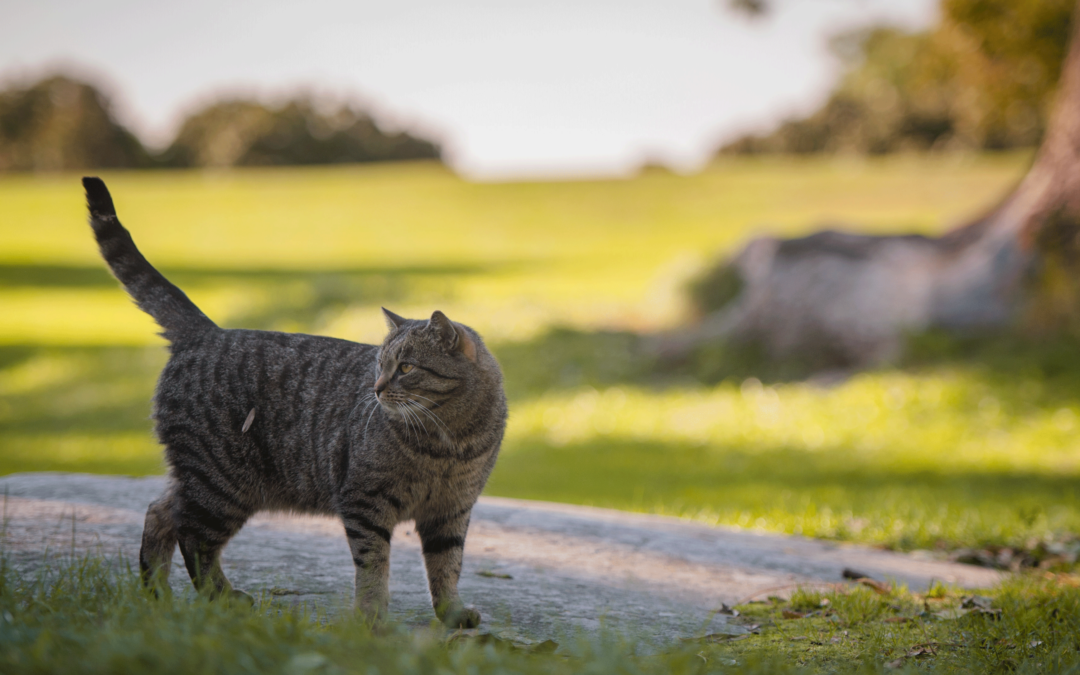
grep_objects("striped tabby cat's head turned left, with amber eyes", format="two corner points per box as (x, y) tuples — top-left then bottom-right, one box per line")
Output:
(375, 308), (502, 435)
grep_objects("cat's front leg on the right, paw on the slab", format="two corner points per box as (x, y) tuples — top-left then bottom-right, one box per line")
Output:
(416, 504), (481, 629)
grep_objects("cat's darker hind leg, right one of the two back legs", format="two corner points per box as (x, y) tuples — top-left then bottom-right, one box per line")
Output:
(177, 476), (254, 602)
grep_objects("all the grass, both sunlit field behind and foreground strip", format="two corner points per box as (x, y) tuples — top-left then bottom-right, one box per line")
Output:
(6, 156), (1080, 673)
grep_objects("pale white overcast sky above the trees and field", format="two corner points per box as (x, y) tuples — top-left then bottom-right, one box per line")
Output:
(0, 0), (936, 180)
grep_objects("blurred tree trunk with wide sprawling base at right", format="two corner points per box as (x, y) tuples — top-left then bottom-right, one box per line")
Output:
(660, 2), (1080, 366)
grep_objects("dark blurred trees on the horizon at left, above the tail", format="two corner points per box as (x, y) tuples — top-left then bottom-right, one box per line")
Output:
(0, 75), (441, 172)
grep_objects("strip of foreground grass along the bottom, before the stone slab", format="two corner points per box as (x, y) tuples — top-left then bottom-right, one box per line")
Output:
(0, 550), (1080, 675)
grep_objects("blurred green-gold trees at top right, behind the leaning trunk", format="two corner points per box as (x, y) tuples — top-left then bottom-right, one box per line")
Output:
(720, 0), (1075, 154)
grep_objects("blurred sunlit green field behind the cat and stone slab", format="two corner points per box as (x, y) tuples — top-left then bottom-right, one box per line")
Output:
(8, 156), (1080, 564)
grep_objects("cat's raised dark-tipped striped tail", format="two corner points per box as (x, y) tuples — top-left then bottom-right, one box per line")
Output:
(82, 177), (217, 342)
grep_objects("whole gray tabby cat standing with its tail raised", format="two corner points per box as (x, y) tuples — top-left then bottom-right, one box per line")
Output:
(82, 178), (507, 627)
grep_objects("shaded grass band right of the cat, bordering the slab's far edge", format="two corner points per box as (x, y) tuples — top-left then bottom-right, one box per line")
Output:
(486, 436), (1080, 550)
